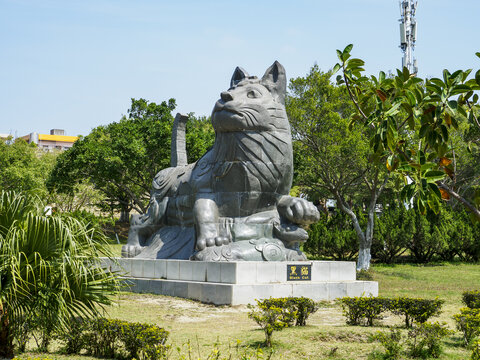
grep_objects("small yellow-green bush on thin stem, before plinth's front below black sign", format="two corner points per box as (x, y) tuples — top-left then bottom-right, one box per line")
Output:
(248, 298), (297, 347)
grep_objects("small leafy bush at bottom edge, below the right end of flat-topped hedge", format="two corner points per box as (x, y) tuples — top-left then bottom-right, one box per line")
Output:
(407, 322), (452, 358)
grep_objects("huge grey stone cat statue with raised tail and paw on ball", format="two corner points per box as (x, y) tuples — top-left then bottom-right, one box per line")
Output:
(122, 62), (320, 261)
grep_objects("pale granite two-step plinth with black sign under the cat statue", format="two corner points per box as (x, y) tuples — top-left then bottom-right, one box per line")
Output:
(103, 258), (378, 305)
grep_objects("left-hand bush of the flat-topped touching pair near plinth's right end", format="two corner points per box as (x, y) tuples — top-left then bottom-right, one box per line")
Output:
(338, 297), (389, 326)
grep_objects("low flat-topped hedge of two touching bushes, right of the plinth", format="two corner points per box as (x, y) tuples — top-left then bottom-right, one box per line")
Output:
(338, 296), (444, 327)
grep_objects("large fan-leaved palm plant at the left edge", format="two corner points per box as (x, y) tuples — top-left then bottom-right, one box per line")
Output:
(0, 192), (119, 357)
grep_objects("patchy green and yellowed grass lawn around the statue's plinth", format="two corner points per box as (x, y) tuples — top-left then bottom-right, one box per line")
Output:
(15, 264), (480, 360)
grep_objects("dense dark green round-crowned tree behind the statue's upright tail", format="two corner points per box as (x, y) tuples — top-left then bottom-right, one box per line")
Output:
(48, 99), (213, 222)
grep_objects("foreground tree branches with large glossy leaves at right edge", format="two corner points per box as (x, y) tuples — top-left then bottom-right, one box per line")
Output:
(334, 45), (480, 219)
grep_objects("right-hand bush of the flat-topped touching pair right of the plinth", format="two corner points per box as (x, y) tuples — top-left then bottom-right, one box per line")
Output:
(388, 297), (445, 328)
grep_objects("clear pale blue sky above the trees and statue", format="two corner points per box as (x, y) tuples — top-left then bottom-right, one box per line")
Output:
(0, 0), (480, 136)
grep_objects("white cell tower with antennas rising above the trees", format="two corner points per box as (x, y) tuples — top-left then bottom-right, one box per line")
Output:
(400, 0), (418, 74)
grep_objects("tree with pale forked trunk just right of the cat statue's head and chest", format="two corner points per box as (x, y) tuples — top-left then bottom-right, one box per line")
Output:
(286, 66), (388, 269)
